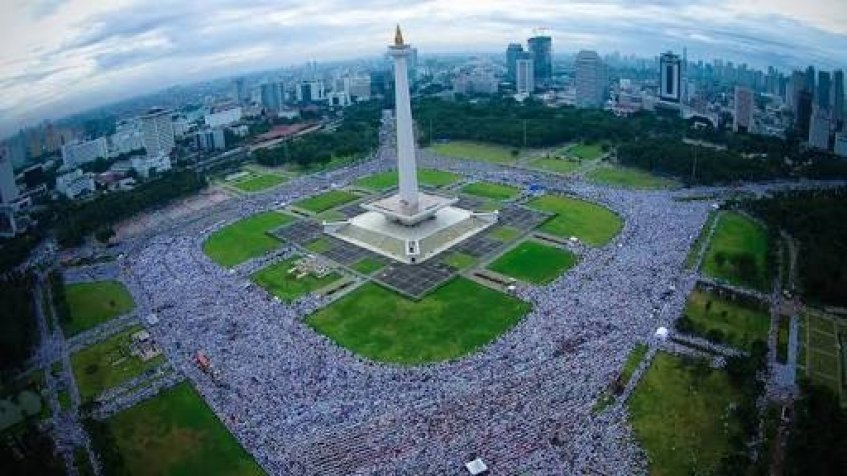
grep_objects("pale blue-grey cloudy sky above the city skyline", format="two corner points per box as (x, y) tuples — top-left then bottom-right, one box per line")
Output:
(0, 0), (847, 137)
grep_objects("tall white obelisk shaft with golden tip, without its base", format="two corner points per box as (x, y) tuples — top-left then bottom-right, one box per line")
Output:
(388, 25), (419, 214)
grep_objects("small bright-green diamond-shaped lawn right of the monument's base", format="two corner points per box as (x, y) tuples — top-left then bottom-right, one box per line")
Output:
(488, 240), (577, 284)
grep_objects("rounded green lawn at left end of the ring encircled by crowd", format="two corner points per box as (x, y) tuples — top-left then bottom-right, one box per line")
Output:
(203, 212), (294, 267)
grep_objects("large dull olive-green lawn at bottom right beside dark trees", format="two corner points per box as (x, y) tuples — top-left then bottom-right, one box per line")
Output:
(629, 352), (742, 475)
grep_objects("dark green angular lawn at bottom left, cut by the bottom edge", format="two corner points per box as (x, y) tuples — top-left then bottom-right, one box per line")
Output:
(99, 383), (263, 475)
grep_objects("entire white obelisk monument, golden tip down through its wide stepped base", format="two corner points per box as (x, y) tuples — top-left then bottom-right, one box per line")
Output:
(324, 26), (497, 264)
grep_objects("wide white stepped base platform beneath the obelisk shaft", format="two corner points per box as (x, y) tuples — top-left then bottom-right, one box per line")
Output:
(324, 206), (497, 264)
